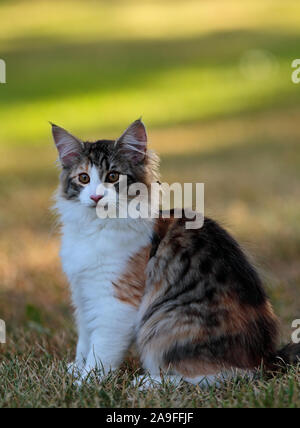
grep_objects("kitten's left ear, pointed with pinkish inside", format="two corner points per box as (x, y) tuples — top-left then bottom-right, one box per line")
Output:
(51, 123), (83, 168)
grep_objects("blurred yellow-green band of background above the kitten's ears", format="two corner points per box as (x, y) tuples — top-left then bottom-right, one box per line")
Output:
(0, 0), (300, 145)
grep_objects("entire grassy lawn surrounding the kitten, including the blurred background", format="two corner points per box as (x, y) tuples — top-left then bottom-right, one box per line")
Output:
(0, 0), (300, 407)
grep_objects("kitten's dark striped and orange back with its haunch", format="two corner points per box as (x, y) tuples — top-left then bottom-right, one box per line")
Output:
(138, 214), (278, 377)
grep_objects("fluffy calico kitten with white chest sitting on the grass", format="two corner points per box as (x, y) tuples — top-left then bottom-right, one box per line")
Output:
(52, 120), (300, 383)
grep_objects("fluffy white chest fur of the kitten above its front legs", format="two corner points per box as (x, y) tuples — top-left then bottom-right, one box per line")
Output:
(59, 200), (151, 311)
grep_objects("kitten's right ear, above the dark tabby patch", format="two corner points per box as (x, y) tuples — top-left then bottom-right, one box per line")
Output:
(116, 119), (148, 163)
